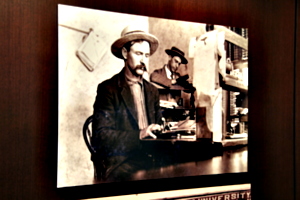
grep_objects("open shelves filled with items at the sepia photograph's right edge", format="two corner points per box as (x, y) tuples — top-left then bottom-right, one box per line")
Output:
(219, 27), (248, 146)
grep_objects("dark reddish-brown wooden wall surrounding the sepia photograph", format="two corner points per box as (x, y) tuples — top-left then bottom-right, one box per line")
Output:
(0, 0), (300, 199)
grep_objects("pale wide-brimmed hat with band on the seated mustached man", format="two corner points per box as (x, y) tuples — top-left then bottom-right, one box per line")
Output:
(111, 25), (159, 59)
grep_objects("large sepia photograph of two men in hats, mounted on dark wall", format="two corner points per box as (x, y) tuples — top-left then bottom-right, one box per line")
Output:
(57, 5), (249, 198)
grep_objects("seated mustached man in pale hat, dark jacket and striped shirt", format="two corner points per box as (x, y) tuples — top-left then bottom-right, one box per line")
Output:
(91, 26), (162, 181)
